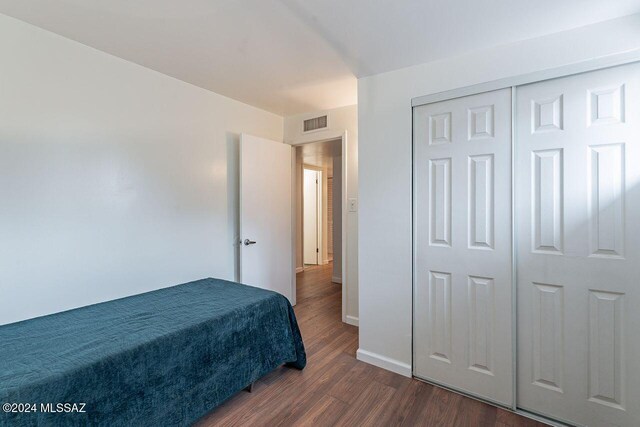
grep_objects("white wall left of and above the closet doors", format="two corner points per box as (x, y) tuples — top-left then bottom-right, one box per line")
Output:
(358, 15), (640, 375)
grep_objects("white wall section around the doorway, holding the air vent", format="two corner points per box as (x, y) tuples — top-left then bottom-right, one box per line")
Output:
(284, 105), (359, 325)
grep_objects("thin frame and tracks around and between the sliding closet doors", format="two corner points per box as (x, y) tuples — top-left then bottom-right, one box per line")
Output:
(409, 49), (640, 426)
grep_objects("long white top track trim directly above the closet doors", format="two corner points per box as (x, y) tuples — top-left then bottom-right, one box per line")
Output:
(411, 49), (640, 107)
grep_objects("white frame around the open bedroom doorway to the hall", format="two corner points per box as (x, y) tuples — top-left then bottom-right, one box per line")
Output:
(292, 129), (353, 324)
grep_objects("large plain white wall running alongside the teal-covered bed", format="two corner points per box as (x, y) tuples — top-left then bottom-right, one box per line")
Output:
(0, 15), (283, 324)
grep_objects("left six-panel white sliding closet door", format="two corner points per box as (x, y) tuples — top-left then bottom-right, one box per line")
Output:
(413, 89), (513, 405)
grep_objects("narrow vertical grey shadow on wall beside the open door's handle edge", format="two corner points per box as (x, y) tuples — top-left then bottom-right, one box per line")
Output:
(225, 132), (240, 281)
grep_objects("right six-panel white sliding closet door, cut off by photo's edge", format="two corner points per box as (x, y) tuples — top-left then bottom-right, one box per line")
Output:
(516, 64), (640, 426)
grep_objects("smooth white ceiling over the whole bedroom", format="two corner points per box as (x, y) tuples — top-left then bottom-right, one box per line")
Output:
(0, 0), (640, 115)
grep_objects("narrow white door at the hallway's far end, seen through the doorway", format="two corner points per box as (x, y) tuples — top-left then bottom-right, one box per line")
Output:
(302, 169), (320, 265)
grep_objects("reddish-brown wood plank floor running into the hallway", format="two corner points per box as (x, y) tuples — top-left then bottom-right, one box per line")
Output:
(197, 264), (543, 427)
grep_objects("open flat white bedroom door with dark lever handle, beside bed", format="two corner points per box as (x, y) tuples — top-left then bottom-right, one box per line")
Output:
(240, 134), (294, 301)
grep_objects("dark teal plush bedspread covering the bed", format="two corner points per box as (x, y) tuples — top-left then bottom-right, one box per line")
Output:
(0, 279), (306, 426)
